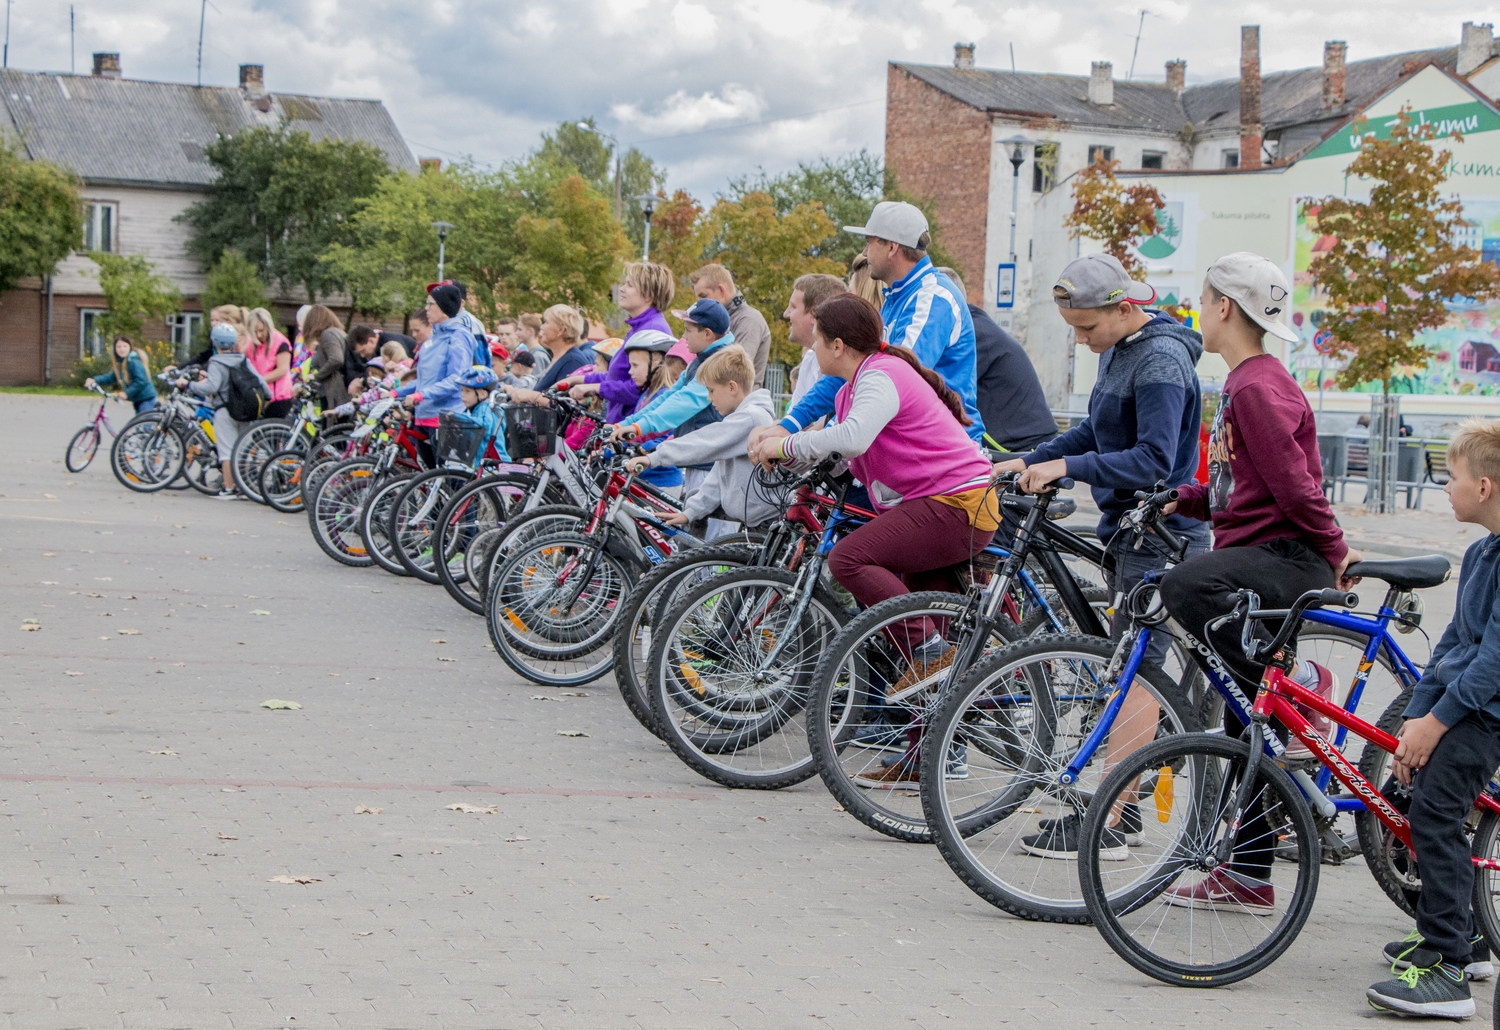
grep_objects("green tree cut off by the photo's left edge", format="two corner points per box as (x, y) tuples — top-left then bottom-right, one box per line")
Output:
(0, 141), (84, 292)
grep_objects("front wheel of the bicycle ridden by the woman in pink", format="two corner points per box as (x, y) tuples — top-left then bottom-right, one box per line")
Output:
(645, 568), (848, 790)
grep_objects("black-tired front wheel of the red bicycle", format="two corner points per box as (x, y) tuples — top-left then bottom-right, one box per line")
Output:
(1079, 733), (1320, 987)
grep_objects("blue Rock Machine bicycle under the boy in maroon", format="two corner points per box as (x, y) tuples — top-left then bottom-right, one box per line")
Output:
(920, 490), (1448, 922)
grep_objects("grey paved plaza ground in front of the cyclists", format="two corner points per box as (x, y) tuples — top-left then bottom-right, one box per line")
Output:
(0, 396), (1491, 1030)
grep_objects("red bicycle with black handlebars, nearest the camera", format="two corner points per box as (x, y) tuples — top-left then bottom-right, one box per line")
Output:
(1079, 589), (1500, 987)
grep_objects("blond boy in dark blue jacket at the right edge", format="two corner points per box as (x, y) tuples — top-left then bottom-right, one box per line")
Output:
(1365, 418), (1500, 1020)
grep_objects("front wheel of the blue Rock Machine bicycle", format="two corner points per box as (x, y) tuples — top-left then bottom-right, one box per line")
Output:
(921, 634), (1199, 922)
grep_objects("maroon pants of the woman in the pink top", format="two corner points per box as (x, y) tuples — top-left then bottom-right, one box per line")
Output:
(828, 498), (995, 649)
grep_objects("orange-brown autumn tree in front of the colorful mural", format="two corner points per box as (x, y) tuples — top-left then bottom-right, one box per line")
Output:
(1305, 106), (1500, 393)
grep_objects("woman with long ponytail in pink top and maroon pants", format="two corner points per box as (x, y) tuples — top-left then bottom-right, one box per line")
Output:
(770, 294), (999, 701)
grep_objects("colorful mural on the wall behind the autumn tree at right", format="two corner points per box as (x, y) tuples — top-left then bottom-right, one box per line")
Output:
(1287, 198), (1500, 396)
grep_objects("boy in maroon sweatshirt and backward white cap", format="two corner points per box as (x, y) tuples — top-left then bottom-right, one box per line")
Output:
(1161, 252), (1361, 912)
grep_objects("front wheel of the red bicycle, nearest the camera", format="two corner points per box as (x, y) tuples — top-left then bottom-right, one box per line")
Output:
(1079, 733), (1320, 987)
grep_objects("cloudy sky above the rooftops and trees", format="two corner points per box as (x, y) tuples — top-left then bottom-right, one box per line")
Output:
(9, 0), (1493, 198)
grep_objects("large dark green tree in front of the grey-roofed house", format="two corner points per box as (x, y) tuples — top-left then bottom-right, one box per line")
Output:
(180, 123), (390, 300)
